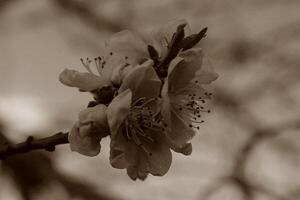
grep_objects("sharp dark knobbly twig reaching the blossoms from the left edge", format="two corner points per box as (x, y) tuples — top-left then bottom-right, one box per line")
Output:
(0, 132), (69, 160)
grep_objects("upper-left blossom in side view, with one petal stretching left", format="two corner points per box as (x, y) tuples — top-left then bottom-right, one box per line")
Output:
(59, 30), (147, 100)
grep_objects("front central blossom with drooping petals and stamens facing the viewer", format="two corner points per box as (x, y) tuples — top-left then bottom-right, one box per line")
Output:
(107, 61), (172, 180)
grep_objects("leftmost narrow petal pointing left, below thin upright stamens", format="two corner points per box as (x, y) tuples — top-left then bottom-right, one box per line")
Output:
(59, 69), (108, 91)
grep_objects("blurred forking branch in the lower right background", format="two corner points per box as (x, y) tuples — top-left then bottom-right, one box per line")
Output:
(201, 88), (300, 200)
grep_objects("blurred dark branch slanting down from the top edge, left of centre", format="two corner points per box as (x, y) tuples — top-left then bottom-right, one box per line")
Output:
(53, 0), (124, 32)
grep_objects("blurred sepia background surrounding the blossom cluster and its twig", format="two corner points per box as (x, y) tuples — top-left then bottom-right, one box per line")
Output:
(0, 0), (300, 200)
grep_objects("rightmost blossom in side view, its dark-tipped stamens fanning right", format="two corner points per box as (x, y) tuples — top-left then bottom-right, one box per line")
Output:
(161, 48), (218, 154)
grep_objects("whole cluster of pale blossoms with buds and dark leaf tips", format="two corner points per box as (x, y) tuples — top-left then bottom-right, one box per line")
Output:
(59, 20), (218, 180)
